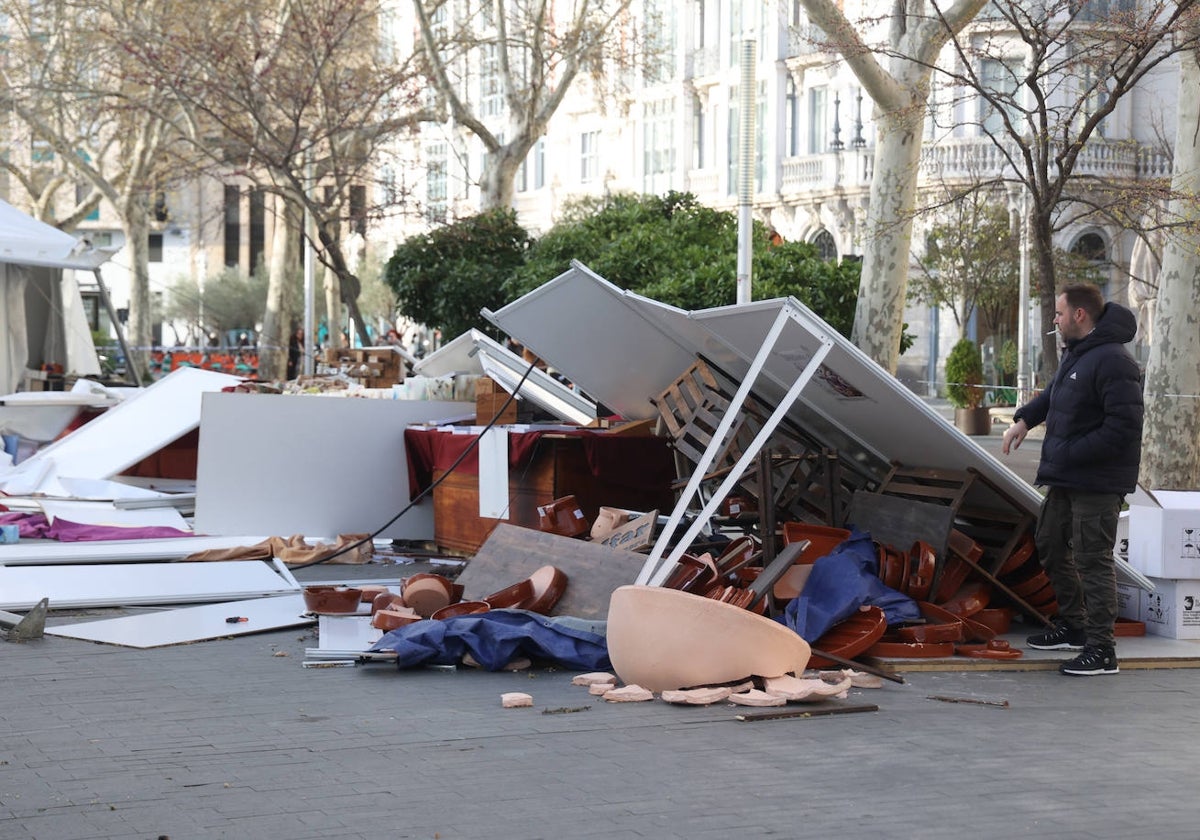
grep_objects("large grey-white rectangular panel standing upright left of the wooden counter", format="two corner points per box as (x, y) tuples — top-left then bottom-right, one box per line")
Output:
(193, 394), (462, 540)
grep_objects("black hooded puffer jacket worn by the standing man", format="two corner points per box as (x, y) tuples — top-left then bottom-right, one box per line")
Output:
(1013, 304), (1142, 493)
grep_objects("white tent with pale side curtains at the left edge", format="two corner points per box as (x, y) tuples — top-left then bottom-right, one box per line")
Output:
(0, 200), (110, 394)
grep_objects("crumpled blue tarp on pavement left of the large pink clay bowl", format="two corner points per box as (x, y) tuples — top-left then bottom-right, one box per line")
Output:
(371, 610), (612, 671)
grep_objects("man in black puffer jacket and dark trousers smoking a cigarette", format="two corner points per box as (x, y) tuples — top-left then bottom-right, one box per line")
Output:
(1002, 283), (1142, 676)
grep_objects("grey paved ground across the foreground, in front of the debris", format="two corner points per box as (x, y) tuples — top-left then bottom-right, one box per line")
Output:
(0, 609), (1200, 840)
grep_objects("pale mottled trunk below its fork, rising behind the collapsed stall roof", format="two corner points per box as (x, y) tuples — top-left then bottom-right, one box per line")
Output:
(851, 107), (925, 373)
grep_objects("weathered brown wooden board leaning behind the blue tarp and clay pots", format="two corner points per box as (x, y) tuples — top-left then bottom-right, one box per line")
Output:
(457, 522), (646, 619)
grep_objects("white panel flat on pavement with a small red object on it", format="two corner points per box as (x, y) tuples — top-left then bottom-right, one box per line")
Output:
(46, 595), (313, 648)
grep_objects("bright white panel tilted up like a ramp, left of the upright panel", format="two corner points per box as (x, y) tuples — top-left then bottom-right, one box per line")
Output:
(5, 367), (241, 479)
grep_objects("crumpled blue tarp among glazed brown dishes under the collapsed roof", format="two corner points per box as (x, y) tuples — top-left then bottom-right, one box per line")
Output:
(776, 529), (920, 642)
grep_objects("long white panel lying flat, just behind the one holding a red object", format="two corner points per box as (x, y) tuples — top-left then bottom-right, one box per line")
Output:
(0, 560), (299, 611)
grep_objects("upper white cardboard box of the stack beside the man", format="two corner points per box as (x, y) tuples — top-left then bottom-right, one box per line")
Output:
(1129, 487), (1200, 580)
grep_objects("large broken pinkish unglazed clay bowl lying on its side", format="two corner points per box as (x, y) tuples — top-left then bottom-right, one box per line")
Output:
(607, 586), (811, 691)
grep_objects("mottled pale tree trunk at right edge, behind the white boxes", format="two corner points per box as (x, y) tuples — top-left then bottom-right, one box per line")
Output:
(1140, 45), (1200, 490)
